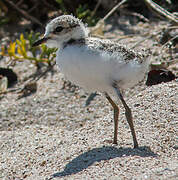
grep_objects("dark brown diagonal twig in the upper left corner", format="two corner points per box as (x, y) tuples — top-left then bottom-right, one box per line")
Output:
(5, 0), (43, 26)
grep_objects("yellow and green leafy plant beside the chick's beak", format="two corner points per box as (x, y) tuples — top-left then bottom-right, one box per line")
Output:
(0, 31), (57, 65)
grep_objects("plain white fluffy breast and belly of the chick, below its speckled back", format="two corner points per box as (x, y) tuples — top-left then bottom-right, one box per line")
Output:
(56, 46), (146, 92)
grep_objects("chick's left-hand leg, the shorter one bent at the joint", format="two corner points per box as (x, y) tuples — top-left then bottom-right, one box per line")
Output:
(105, 93), (119, 144)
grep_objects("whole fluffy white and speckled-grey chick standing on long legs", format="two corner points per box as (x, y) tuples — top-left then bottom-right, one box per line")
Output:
(34, 15), (149, 148)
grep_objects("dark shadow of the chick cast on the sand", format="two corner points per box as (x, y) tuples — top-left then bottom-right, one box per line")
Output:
(51, 146), (157, 179)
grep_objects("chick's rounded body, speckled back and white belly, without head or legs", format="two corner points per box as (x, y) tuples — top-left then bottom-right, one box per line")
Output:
(56, 37), (148, 94)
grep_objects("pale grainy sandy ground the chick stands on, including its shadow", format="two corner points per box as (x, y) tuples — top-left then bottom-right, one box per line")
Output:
(0, 14), (178, 180)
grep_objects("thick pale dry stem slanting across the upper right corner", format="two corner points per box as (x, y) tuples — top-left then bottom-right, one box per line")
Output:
(144, 0), (178, 24)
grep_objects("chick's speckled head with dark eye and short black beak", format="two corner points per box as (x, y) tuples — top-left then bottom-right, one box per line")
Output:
(33, 15), (88, 48)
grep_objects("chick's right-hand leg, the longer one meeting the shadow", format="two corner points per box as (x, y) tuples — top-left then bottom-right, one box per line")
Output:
(113, 86), (138, 148)
